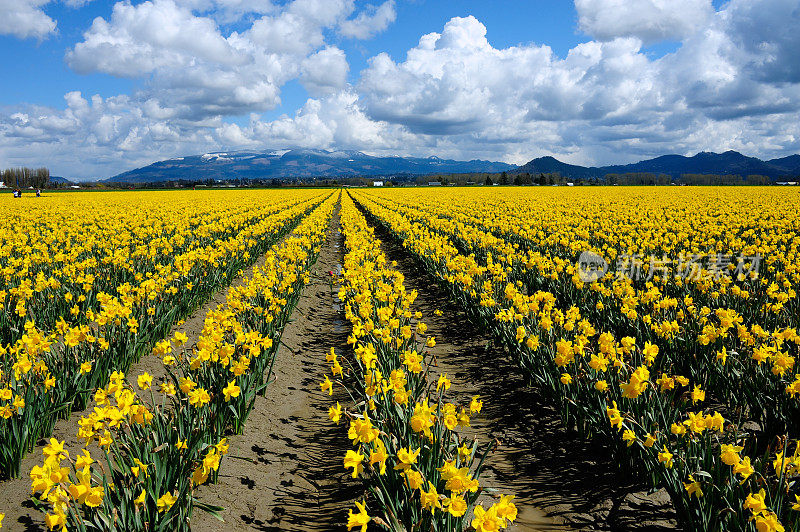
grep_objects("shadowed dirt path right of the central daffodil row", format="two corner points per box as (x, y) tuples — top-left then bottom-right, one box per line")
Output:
(362, 212), (677, 532)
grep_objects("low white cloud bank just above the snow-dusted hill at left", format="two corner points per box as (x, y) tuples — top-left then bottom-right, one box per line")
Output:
(0, 90), (412, 179)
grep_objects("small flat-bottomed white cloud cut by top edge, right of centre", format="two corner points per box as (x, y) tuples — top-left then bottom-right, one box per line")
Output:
(575, 0), (714, 42)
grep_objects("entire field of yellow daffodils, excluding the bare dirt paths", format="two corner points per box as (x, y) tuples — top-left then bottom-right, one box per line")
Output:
(0, 187), (800, 532)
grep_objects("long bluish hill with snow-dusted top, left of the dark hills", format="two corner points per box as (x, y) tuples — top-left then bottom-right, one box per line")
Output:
(106, 150), (515, 183)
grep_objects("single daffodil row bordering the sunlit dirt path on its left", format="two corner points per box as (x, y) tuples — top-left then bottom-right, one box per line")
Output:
(30, 194), (337, 531)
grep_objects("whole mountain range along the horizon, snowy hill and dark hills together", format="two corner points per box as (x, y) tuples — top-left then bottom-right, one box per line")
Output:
(100, 149), (800, 183)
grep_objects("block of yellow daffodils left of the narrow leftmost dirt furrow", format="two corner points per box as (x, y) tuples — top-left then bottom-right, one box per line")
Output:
(0, 191), (324, 479)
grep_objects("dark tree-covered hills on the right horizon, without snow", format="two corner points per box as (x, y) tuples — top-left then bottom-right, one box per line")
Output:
(514, 150), (800, 180)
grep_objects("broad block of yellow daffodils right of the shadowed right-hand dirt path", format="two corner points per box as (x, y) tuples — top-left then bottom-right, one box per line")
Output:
(355, 189), (800, 532)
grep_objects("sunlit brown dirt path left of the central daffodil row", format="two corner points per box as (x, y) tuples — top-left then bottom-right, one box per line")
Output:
(192, 210), (359, 531)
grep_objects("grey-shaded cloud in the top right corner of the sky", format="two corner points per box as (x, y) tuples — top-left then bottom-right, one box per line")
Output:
(658, 0), (800, 120)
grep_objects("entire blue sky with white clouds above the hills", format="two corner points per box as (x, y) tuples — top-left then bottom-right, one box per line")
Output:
(0, 0), (800, 179)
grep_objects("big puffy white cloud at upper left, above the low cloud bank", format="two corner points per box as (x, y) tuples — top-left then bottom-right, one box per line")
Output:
(67, 0), (290, 119)
